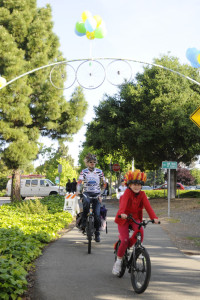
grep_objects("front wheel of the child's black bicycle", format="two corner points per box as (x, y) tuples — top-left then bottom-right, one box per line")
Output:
(131, 248), (151, 294)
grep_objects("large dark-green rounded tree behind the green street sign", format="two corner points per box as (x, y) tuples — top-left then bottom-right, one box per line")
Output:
(86, 56), (200, 196)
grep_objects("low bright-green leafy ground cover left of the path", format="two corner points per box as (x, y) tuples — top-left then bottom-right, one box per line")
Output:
(0, 196), (72, 300)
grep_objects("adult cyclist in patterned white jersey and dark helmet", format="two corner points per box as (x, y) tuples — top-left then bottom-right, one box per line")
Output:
(76, 153), (106, 242)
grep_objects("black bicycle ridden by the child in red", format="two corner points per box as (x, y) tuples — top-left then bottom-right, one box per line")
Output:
(114, 216), (160, 294)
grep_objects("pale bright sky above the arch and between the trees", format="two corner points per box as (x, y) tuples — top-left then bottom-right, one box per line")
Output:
(36, 0), (200, 165)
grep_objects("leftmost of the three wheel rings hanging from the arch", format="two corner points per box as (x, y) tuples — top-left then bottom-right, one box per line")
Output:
(50, 63), (76, 90)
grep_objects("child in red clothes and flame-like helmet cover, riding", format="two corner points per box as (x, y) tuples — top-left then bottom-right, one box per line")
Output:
(112, 170), (159, 275)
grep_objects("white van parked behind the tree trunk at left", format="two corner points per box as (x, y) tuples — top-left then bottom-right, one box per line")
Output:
(6, 178), (65, 199)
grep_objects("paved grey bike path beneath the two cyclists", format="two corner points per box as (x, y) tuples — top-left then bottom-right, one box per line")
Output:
(31, 201), (200, 300)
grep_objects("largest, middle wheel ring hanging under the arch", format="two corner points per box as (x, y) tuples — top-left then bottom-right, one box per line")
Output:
(76, 60), (106, 89)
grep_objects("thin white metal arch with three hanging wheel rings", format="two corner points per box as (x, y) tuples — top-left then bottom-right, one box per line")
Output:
(0, 58), (200, 90)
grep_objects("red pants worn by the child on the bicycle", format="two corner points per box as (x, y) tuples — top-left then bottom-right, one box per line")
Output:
(117, 220), (144, 257)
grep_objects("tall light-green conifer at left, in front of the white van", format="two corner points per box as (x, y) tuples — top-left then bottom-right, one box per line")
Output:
(0, 0), (87, 200)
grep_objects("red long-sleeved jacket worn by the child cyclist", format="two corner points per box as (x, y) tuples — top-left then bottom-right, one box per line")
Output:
(115, 188), (157, 225)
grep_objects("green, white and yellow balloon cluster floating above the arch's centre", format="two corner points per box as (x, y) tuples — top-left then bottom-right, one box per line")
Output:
(75, 10), (106, 40)
